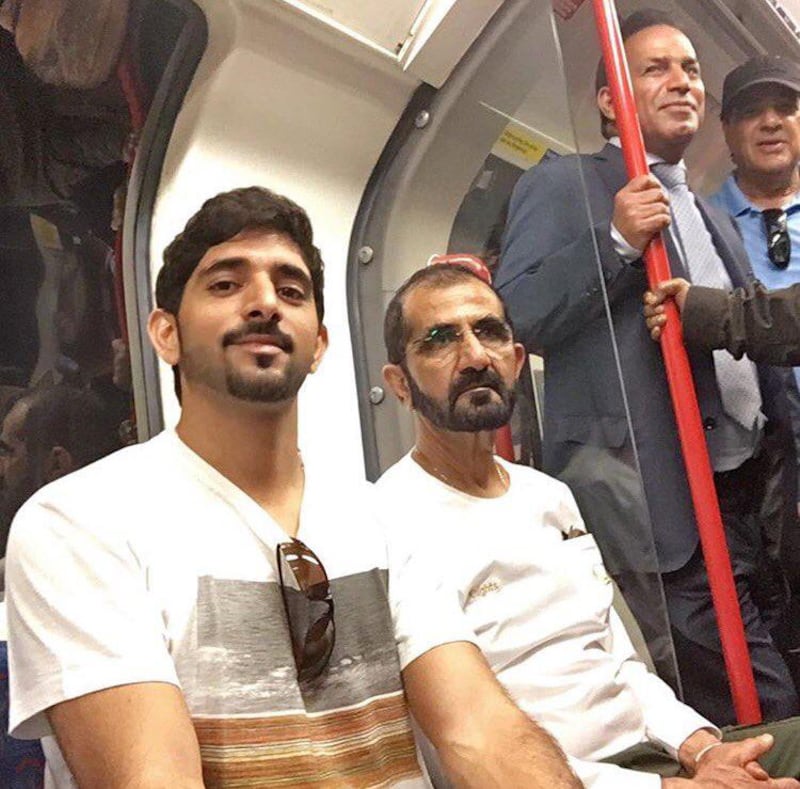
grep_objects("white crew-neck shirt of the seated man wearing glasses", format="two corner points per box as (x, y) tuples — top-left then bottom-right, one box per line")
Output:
(375, 455), (717, 789)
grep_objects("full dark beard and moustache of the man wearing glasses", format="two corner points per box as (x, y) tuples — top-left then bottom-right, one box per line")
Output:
(405, 368), (515, 433)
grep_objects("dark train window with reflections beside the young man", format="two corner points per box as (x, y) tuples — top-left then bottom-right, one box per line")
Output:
(0, 0), (205, 556)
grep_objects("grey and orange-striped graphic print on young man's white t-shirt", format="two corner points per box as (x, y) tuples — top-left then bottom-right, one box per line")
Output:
(183, 569), (420, 789)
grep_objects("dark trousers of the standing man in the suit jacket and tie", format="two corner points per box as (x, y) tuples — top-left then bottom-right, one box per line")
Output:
(662, 458), (800, 726)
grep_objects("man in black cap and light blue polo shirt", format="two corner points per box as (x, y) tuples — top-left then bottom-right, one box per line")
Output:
(712, 55), (800, 524)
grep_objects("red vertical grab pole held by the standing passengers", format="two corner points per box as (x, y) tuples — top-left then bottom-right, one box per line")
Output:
(592, 0), (761, 724)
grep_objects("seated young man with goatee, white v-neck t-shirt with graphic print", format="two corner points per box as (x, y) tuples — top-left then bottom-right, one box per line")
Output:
(7, 187), (579, 789)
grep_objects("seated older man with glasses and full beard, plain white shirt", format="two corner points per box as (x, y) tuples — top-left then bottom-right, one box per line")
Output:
(376, 261), (800, 789)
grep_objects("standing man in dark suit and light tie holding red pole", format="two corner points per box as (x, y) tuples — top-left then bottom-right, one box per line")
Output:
(496, 11), (798, 724)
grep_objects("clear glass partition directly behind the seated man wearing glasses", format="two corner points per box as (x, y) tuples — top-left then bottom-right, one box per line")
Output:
(350, 0), (680, 691)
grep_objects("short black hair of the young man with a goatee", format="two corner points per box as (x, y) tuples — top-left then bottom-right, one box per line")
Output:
(156, 186), (325, 323)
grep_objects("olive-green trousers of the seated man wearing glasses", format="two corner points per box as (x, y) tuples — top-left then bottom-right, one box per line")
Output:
(603, 718), (800, 778)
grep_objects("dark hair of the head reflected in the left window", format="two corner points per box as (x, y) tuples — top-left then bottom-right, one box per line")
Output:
(17, 384), (122, 472)
